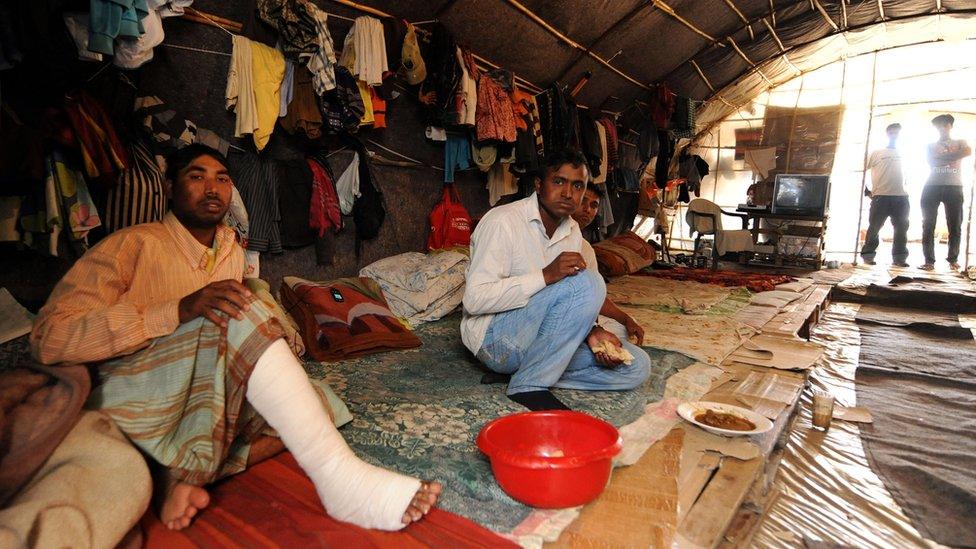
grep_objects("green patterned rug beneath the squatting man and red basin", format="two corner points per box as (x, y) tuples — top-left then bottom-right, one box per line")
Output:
(306, 314), (693, 532)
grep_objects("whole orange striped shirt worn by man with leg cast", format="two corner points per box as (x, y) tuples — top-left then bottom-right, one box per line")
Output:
(30, 212), (245, 364)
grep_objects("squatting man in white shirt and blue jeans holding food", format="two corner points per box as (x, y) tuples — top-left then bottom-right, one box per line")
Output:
(461, 151), (650, 410)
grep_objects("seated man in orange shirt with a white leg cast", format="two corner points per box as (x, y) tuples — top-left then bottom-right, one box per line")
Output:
(30, 145), (441, 530)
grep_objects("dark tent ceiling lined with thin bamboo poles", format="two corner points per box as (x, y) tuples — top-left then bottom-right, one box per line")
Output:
(346, 0), (976, 116)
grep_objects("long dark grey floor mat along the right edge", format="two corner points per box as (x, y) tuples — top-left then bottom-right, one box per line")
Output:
(856, 306), (976, 546)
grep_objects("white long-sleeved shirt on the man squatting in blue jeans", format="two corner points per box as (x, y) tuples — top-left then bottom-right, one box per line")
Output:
(461, 193), (583, 354)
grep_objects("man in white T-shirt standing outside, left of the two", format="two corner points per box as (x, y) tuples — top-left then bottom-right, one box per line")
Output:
(861, 123), (911, 267)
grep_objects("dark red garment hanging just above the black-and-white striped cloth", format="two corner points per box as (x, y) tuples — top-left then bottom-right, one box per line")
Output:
(64, 91), (130, 184)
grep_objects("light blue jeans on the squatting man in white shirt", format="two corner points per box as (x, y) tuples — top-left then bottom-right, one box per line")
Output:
(478, 270), (651, 395)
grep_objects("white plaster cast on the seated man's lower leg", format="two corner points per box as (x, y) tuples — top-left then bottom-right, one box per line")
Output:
(247, 339), (420, 530)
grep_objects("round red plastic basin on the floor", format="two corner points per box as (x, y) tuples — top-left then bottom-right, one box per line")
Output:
(477, 410), (622, 509)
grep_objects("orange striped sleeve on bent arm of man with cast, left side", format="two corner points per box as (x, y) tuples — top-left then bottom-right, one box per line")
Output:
(30, 239), (179, 364)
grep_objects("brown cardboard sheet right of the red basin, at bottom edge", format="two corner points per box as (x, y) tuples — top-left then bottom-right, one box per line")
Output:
(546, 429), (685, 547)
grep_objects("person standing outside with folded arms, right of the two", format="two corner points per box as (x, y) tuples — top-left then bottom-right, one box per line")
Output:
(921, 114), (973, 271)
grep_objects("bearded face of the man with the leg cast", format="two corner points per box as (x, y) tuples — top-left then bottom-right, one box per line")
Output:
(169, 155), (234, 228)
